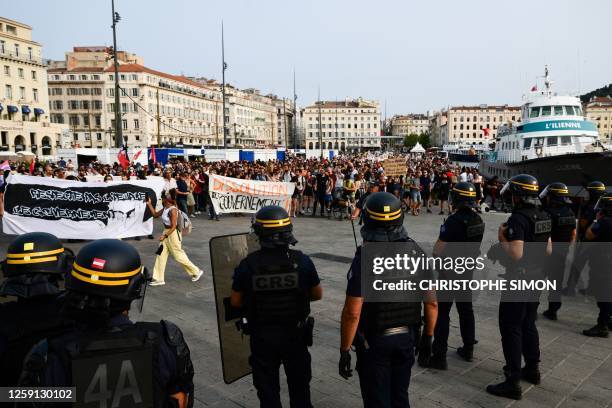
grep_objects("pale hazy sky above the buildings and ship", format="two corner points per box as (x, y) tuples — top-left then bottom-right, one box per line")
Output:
(0, 0), (612, 116)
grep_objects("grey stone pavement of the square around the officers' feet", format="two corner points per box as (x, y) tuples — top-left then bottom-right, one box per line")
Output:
(0, 213), (612, 408)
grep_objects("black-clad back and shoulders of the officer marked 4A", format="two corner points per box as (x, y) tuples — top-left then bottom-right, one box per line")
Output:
(20, 320), (193, 408)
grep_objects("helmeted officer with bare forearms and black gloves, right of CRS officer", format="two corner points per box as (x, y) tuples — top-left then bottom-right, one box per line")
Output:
(338, 192), (437, 408)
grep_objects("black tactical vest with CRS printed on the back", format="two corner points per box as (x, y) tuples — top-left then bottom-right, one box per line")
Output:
(245, 249), (310, 328)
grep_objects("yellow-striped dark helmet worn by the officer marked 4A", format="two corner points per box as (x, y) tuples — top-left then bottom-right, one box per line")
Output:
(66, 239), (148, 305)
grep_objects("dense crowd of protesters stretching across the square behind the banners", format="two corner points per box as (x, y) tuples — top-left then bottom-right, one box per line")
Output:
(0, 154), (506, 220)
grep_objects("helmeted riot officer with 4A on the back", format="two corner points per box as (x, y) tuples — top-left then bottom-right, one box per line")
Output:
(20, 239), (194, 408)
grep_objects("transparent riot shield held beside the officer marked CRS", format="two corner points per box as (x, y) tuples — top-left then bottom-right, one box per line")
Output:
(210, 233), (259, 384)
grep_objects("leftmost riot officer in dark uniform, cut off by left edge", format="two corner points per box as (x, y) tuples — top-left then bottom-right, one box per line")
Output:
(0, 232), (74, 386)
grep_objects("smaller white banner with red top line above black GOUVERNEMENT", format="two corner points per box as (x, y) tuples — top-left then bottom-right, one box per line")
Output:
(209, 174), (295, 214)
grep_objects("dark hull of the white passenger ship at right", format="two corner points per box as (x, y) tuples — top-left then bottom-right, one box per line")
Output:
(479, 151), (612, 195)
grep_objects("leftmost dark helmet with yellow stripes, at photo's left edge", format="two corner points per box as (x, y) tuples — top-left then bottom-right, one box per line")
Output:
(0, 232), (74, 298)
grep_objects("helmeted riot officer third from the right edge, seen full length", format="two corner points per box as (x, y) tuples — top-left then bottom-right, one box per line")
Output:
(540, 182), (576, 320)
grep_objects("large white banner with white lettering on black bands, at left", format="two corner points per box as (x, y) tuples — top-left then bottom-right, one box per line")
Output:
(2, 175), (164, 239)
